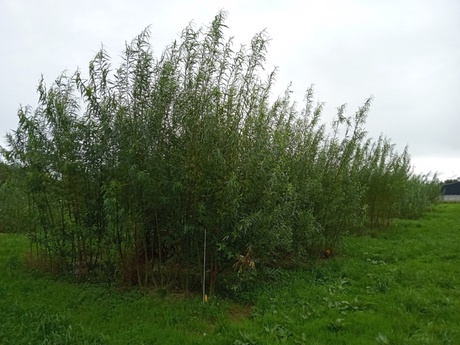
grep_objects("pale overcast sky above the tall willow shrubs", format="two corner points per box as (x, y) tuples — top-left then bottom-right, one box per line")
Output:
(0, 0), (460, 180)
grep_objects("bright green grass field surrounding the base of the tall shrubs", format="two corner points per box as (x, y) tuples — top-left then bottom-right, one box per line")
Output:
(0, 204), (460, 345)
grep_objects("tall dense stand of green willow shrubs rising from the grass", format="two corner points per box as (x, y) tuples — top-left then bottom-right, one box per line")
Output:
(0, 13), (439, 293)
